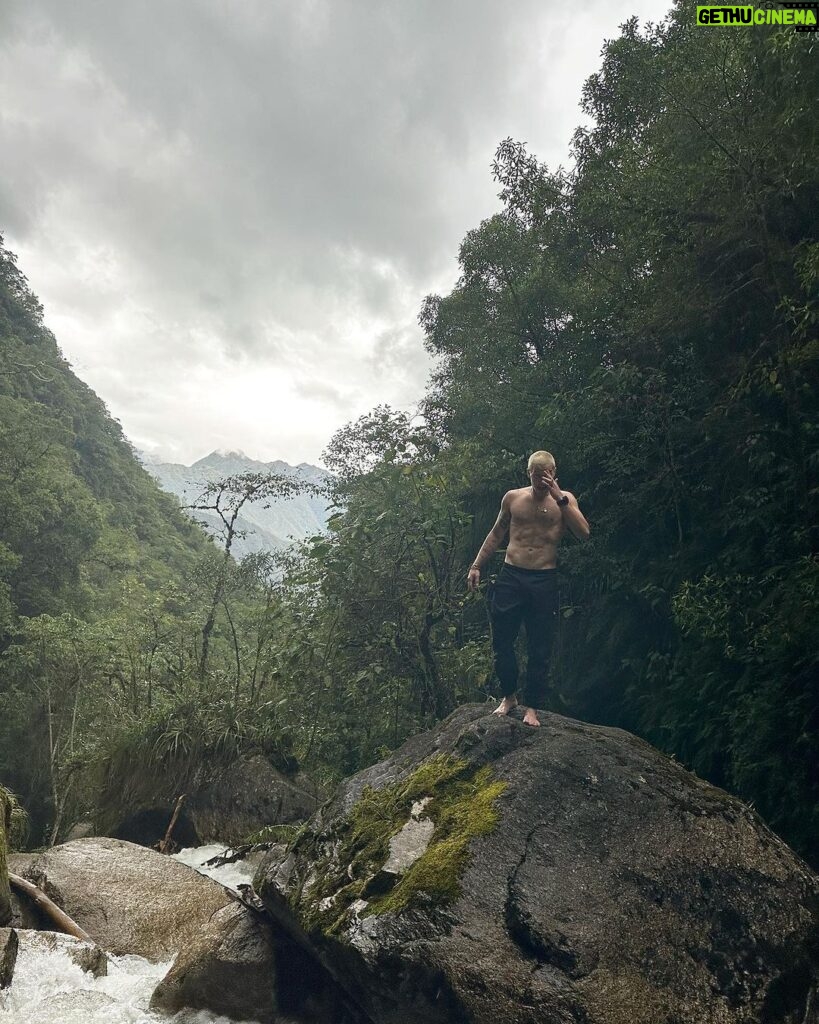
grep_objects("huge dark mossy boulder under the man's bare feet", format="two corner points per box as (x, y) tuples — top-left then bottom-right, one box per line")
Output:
(256, 706), (819, 1024)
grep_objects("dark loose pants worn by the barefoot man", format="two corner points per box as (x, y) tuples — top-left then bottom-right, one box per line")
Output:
(489, 563), (558, 708)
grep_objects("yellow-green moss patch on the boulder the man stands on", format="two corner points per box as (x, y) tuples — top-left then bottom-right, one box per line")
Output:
(295, 755), (506, 935)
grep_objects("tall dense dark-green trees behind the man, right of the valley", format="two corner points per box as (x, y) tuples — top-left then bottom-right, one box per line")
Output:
(268, 4), (819, 862)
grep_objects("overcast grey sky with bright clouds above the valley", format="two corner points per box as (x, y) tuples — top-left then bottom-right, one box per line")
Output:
(0, 0), (670, 463)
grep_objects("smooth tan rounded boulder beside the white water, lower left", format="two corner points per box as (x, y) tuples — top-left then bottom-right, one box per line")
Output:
(10, 838), (230, 962)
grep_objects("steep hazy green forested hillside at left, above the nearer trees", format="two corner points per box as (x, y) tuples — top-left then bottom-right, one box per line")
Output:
(0, 239), (210, 615)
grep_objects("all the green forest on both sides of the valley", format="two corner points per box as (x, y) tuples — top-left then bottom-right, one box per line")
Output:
(0, 3), (819, 863)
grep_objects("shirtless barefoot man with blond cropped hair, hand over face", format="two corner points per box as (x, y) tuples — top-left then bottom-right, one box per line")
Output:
(467, 452), (590, 726)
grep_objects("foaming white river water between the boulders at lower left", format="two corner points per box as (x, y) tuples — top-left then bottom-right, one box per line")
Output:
(0, 846), (259, 1024)
